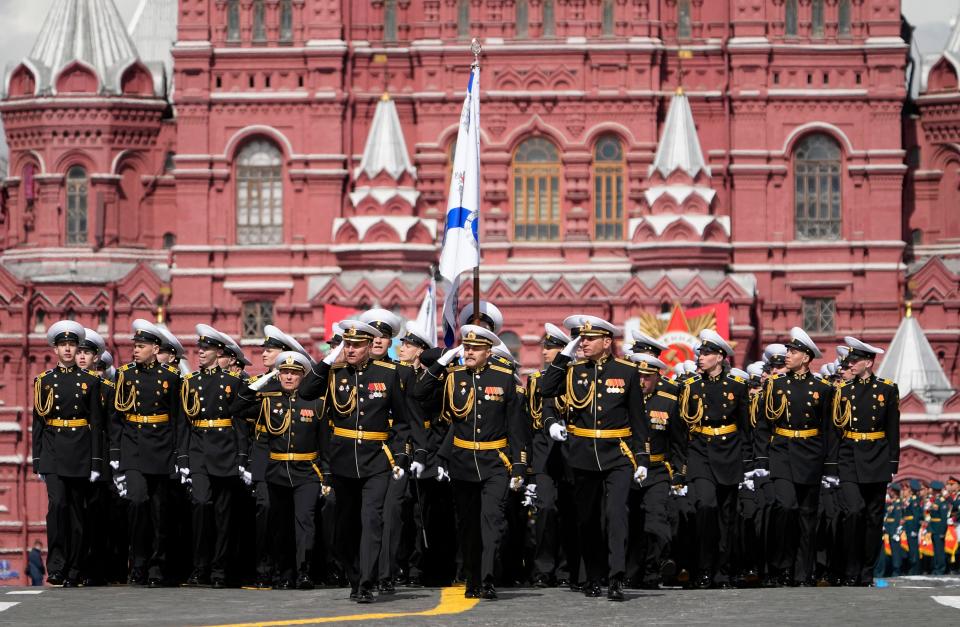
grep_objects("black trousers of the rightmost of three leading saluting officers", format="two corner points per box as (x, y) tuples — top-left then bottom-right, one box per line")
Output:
(573, 466), (633, 584)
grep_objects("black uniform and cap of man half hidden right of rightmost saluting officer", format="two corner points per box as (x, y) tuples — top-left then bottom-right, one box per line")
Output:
(630, 355), (687, 589)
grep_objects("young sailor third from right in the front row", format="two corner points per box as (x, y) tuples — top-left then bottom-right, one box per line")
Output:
(680, 329), (753, 588)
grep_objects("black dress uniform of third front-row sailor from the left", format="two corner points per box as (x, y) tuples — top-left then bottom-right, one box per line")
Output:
(177, 360), (247, 587)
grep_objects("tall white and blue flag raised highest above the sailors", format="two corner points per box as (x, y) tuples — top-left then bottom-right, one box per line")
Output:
(440, 66), (480, 284)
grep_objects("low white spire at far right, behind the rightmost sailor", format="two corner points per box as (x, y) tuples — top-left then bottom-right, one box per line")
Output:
(877, 314), (953, 403)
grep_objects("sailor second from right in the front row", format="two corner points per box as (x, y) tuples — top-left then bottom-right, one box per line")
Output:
(756, 327), (836, 586)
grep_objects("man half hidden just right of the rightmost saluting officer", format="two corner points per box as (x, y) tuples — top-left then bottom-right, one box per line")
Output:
(630, 356), (687, 590)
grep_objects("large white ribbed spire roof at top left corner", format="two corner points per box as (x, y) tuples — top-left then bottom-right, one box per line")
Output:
(24, 0), (146, 95)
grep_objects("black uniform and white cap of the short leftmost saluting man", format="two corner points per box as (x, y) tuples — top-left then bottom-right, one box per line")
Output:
(233, 352), (327, 590)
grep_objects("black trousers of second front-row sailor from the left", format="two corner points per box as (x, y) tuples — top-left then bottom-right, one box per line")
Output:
(126, 470), (172, 579)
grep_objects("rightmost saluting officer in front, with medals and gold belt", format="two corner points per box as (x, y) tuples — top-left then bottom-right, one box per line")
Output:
(542, 316), (650, 601)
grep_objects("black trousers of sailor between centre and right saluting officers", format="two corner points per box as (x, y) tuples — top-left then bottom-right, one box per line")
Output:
(533, 473), (580, 583)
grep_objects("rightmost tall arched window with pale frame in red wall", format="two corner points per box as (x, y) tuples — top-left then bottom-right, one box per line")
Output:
(793, 133), (842, 240)
